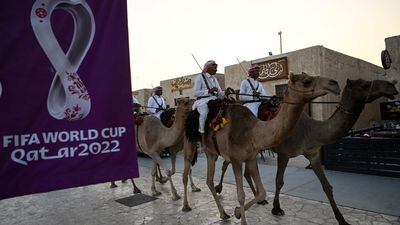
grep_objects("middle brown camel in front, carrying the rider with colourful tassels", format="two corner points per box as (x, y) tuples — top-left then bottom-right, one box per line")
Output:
(182, 73), (340, 224)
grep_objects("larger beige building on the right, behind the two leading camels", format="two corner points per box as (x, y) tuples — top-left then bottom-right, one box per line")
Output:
(225, 46), (387, 129)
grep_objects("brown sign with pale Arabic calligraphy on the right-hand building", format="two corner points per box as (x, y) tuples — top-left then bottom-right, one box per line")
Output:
(256, 57), (289, 81)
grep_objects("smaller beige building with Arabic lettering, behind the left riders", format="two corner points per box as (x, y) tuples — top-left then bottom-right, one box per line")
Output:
(160, 73), (225, 107)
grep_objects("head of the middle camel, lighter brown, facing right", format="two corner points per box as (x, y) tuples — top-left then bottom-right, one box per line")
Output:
(288, 72), (340, 102)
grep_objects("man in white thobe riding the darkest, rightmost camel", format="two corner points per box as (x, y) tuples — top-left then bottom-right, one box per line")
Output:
(239, 65), (267, 117)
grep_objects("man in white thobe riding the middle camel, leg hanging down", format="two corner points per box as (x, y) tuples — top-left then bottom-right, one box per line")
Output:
(193, 60), (224, 143)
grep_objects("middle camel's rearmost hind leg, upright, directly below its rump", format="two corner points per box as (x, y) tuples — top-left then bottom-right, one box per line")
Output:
(182, 138), (196, 212)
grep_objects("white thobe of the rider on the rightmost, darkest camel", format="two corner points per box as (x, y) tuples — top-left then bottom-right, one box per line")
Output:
(239, 77), (267, 117)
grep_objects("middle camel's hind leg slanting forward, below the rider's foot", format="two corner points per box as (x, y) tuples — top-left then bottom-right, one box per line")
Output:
(206, 151), (230, 220)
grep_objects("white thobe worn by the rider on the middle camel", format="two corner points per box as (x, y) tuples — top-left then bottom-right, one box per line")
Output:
(192, 73), (224, 133)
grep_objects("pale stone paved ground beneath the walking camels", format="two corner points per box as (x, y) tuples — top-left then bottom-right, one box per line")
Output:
(0, 152), (400, 225)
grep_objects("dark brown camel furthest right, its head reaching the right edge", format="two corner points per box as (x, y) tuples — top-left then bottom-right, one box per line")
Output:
(216, 79), (398, 225)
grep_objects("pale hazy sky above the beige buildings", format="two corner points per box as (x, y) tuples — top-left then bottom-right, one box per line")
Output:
(127, 0), (400, 90)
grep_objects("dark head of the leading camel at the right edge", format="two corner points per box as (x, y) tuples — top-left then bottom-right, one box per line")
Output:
(344, 79), (399, 103)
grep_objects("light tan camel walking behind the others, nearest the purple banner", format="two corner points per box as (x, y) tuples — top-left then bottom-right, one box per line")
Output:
(137, 98), (200, 200)
